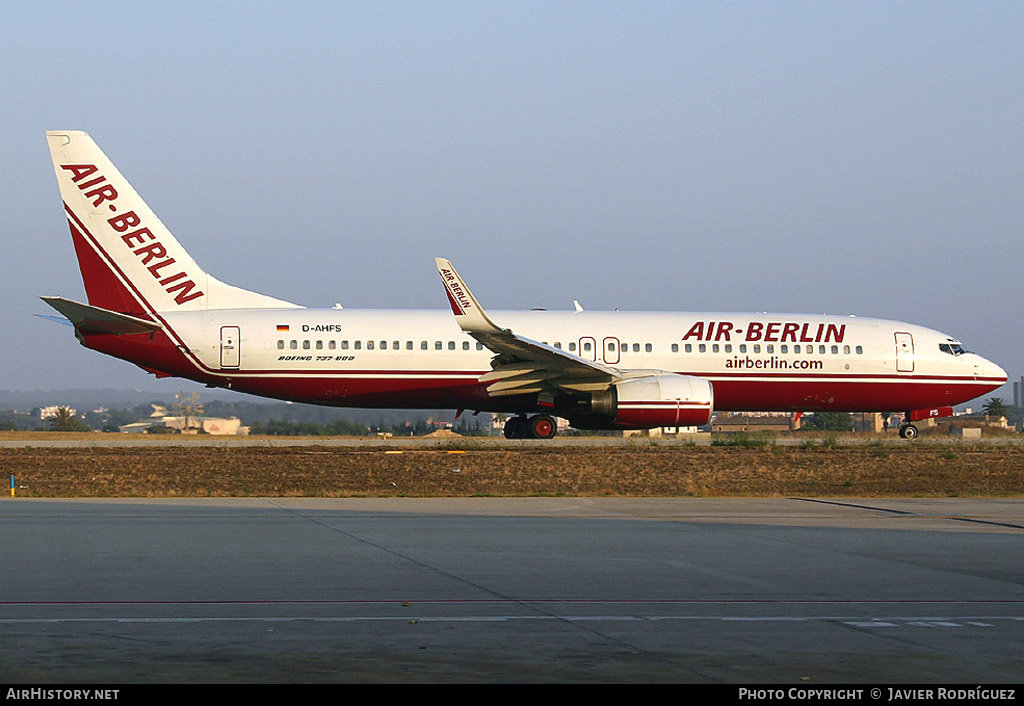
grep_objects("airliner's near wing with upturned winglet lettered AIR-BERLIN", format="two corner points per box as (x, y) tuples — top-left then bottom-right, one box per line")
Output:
(434, 257), (625, 397)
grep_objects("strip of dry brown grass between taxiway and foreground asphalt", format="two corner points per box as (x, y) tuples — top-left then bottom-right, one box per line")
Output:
(0, 444), (1024, 498)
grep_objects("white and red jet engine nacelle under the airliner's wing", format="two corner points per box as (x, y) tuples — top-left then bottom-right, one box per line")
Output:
(581, 373), (715, 429)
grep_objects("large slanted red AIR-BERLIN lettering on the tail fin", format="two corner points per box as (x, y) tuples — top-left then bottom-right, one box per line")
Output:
(60, 164), (203, 304)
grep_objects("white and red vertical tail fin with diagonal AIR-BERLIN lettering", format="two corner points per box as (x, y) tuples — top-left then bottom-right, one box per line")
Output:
(46, 130), (298, 316)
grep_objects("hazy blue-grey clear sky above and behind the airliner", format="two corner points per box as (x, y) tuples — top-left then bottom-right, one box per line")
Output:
(0, 0), (1024, 397)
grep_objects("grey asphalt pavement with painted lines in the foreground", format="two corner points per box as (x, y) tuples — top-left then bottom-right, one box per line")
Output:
(0, 498), (1024, 686)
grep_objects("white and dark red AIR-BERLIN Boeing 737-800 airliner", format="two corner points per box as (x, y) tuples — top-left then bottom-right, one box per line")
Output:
(43, 131), (1007, 439)
